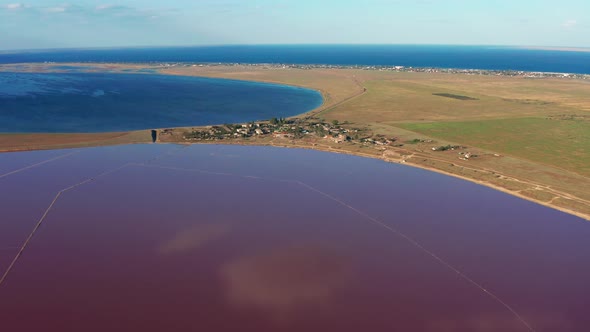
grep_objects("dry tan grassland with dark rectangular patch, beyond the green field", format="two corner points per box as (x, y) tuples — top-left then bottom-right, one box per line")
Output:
(322, 72), (590, 123)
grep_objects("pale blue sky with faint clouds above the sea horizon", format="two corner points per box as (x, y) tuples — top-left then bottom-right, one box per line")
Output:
(0, 0), (590, 50)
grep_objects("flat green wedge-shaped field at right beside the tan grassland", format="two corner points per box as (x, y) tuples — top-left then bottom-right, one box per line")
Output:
(398, 118), (590, 176)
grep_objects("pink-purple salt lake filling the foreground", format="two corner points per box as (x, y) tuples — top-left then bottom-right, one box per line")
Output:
(0, 145), (590, 332)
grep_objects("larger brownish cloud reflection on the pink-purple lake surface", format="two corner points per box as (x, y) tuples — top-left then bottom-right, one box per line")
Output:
(222, 246), (351, 319)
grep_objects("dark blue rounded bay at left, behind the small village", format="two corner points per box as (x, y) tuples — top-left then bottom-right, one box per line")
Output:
(0, 72), (322, 133)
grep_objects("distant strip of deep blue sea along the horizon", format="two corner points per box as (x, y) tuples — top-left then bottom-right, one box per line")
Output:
(0, 45), (590, 74)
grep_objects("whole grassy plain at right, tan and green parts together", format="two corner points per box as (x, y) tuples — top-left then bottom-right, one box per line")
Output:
(314, 72), (590, 176)
